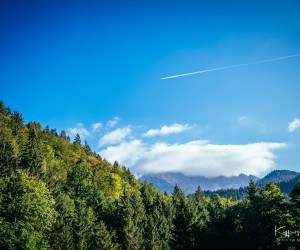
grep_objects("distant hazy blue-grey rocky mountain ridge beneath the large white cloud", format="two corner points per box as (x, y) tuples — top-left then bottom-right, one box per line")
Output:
(140, 172), (259, 194)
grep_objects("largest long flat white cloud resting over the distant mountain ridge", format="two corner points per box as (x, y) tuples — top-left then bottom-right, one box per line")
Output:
(99, 140), (286, 176)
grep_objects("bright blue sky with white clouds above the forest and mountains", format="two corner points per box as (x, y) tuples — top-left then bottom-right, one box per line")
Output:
(0, 1), (300, 176)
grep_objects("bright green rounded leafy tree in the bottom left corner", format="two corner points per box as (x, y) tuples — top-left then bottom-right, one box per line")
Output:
(0, 171), (57, 249)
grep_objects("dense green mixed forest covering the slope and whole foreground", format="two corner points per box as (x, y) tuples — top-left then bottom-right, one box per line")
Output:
(0, 102), (300, 250)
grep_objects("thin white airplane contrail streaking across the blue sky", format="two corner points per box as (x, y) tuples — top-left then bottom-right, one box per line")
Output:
(161, 54), (300, 80)
